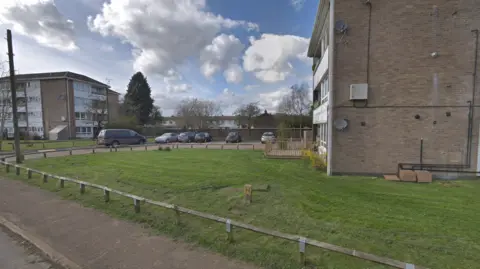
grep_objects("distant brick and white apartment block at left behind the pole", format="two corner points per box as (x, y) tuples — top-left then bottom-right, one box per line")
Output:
(0, 72), (119, 139)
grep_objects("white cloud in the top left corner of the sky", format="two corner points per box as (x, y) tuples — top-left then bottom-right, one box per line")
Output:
(0, 0), (78, 51)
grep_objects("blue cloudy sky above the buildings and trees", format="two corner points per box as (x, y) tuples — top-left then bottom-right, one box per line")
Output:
(0, 0), (319, 116)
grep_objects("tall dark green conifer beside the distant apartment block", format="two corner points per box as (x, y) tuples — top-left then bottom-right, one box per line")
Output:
(124, 72), (153, 125)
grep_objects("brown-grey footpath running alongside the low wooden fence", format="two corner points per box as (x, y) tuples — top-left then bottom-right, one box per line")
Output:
(0, 179), (255, 269)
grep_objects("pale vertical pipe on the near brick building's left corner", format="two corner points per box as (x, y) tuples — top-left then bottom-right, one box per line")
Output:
(327, 0), (335, 176)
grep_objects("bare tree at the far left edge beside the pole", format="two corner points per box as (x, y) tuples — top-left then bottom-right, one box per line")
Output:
(0, 63), (12, 150)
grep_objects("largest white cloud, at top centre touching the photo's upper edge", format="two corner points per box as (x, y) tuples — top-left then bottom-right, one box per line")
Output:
(88, 0), (258, 75)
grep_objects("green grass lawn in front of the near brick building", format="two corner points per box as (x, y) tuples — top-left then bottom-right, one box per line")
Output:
(5, 149), (480, 268)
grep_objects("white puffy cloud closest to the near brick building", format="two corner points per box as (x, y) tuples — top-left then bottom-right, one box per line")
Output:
(243, 34), (309, 83)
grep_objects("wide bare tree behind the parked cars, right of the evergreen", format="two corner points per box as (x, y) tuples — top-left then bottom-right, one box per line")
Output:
(175, 98), (221, 129)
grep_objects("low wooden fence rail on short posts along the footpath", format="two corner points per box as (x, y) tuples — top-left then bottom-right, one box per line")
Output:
(0, 155), (426, 269)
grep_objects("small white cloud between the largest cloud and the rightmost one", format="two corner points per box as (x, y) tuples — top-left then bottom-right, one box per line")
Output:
(200, 34), (245, 83)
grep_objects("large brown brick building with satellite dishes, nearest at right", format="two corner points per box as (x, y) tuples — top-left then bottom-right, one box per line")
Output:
(308, 0), (480, 177)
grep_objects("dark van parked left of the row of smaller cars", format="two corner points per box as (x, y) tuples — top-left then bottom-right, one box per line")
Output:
(97, 129), (147, 147)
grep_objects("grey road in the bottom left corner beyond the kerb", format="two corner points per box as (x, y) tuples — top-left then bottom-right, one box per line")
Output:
(0, 226), (59, 269)
